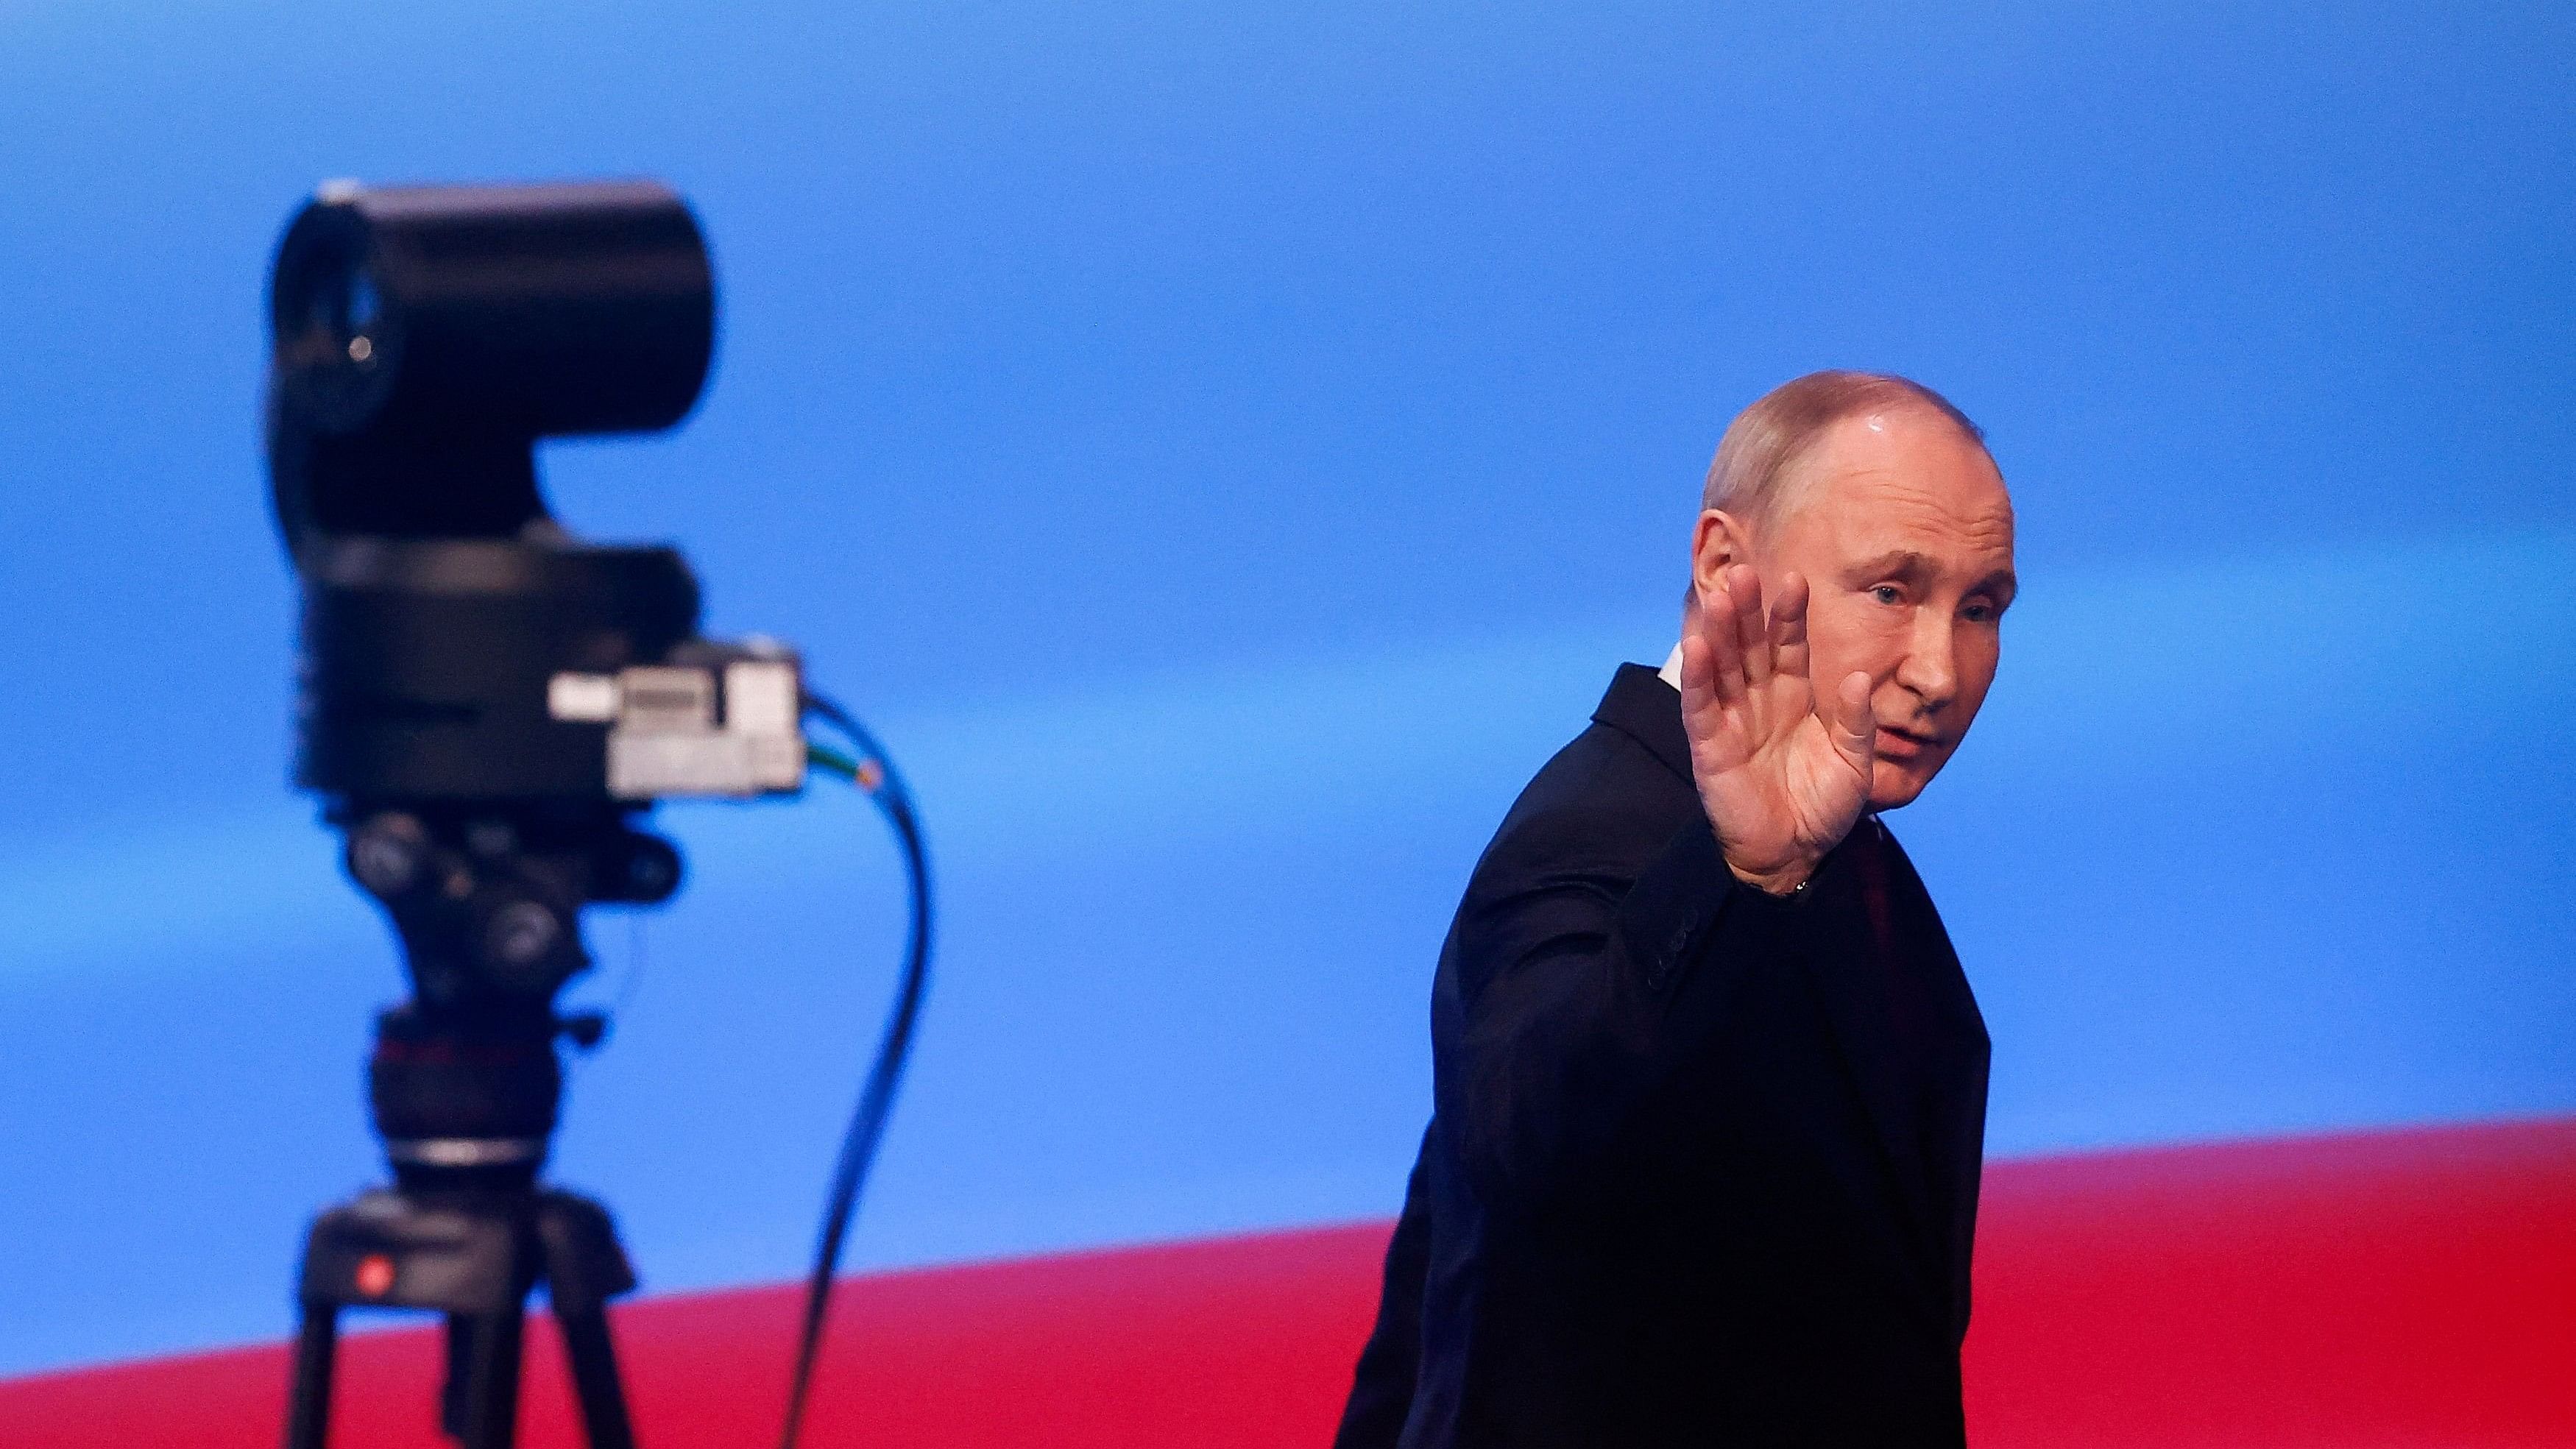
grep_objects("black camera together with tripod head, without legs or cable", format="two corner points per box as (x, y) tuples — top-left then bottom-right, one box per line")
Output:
(268, 183), (807, 1176)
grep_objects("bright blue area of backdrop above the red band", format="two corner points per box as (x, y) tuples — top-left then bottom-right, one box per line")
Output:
(0, 0), (2576, 1372)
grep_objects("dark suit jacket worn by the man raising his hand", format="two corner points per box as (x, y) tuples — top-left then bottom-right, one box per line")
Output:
(1337, 664), (1986, 1449)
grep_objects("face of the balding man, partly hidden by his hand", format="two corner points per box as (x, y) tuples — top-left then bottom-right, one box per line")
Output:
(1752, 407), (2014, 811)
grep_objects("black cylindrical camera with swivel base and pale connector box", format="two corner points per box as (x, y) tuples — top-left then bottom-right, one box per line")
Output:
(268, 183), (804, 806)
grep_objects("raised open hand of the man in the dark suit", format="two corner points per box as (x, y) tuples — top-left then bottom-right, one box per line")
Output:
(1682, 564), (1875, 893)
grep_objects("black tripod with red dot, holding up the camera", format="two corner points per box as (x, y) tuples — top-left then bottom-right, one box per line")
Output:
(286, 811), (678, 1449)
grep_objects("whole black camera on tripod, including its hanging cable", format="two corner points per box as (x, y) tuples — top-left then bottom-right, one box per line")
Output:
(266, 180), (930, 1449)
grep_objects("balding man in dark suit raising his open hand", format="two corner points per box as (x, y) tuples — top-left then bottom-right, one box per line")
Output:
(1337, 373), (2014, 1449)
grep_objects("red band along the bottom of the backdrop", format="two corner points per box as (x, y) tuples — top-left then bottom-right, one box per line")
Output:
(0, 1119), (2576, 1449)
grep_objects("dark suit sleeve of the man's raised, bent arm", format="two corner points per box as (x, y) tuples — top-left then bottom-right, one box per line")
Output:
(1435, 813), (1803, 1202)
